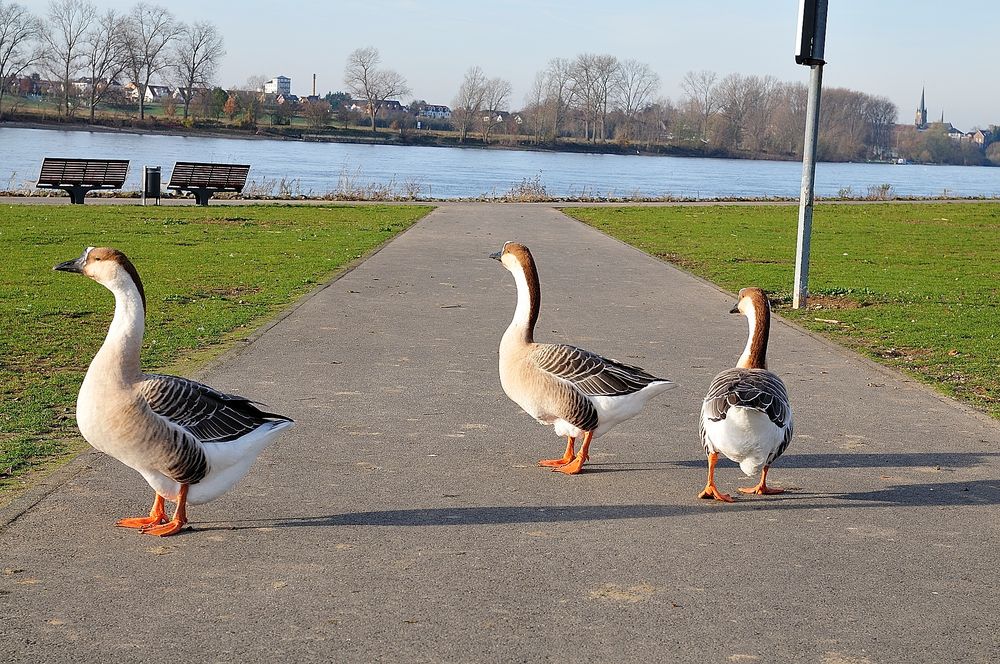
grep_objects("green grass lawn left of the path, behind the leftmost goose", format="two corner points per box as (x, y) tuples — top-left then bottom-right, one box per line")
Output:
(0, 205), (432, 499)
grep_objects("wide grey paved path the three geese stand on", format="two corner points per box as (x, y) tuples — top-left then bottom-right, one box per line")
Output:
(0, 204), (1000, 664)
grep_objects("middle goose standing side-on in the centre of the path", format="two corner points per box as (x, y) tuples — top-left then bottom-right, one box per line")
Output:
(490, 242), (674, 475)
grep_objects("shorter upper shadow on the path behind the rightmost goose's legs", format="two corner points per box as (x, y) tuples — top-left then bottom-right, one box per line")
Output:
(653, 452), (1000, 470)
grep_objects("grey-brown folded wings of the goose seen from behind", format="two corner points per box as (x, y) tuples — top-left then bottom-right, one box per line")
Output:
(701, 369), (792, 462)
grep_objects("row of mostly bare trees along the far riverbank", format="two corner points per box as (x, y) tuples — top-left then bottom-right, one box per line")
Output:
(0, 0), (1000, 163)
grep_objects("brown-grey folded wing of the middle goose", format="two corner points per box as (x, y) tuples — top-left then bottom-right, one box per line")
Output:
(530, 344), (666, 397)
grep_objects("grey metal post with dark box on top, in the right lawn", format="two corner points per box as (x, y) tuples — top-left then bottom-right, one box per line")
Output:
(792, 0), (827, 309)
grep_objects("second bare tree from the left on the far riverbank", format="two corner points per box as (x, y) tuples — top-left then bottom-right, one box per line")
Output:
(45, 0), (97, 115)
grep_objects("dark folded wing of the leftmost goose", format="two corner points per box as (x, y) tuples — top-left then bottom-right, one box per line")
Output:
(139, 374), (290, 443)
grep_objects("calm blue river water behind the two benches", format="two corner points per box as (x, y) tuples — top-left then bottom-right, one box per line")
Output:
(0, 127), (1000, 199)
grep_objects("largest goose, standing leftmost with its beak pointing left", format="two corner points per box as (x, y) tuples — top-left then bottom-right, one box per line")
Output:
(53, 247), (293, 537)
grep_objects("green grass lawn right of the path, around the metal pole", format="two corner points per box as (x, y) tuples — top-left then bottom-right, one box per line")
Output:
(564, 203), (1000, 417)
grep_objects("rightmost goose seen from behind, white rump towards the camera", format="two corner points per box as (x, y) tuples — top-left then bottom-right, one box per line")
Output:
(698, 288), (792, 503)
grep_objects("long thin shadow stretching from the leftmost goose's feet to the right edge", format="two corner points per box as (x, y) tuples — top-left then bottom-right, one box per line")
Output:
(191, 480), (1000, 531)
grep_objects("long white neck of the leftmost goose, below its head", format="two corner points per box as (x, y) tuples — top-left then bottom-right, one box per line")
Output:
(88, 281), (146, 383)
